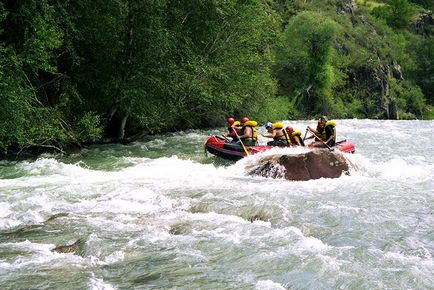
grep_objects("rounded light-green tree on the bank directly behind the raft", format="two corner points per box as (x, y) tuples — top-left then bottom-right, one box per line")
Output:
(276, 12), (339, 115)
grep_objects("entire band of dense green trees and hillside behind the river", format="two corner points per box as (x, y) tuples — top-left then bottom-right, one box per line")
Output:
(0, 0), (434, 153)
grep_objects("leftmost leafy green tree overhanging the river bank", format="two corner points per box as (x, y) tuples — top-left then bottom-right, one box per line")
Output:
(0, 0), (103, 152)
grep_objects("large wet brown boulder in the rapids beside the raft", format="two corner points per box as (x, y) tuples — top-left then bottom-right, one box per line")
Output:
(246, 149), (349, 180)
